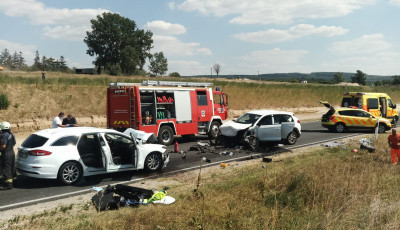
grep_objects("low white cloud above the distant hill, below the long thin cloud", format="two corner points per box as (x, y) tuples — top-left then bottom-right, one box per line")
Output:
(230, 48), (310, 74)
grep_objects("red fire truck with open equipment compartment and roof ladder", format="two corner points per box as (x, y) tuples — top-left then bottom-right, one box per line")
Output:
(107, 81), (228, 145)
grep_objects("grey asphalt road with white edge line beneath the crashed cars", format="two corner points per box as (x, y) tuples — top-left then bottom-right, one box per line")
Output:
(0, 122), (376, 210)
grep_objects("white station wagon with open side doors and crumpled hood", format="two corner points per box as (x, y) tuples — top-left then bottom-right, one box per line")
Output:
(16, 127), (169, 185)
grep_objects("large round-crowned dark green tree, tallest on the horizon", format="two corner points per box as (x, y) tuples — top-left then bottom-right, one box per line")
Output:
(83, 13), (153, 74)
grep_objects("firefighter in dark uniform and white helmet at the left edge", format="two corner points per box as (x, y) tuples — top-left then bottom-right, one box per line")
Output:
(0, 122), (16, 190)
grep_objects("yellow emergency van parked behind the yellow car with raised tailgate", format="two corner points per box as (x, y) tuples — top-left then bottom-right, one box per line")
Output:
(342, 92), (399, 125)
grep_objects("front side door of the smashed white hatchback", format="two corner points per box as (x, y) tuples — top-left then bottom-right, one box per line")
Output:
(255, 115), (281, 141)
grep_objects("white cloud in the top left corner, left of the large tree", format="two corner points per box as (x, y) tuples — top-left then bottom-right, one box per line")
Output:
(0, 0), (109, 41)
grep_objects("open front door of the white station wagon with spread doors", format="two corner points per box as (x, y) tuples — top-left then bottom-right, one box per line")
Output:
(104, 133), (137, 172)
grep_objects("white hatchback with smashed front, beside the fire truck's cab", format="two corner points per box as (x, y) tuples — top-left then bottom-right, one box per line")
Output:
(219, 110), (301, 147)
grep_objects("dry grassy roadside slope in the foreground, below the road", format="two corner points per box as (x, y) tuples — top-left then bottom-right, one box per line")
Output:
(4, 135), (400, 229)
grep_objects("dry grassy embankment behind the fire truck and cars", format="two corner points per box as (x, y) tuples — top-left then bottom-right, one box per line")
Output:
(0, 72), (400, 122)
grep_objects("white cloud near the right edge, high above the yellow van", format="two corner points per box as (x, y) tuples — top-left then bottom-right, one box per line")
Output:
(330, 34), (392, 55)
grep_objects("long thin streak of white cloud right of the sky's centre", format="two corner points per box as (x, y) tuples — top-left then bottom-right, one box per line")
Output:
(234, 24), (348, 44)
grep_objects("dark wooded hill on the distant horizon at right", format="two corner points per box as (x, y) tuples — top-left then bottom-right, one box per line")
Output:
(187, 72), (392, 82)
